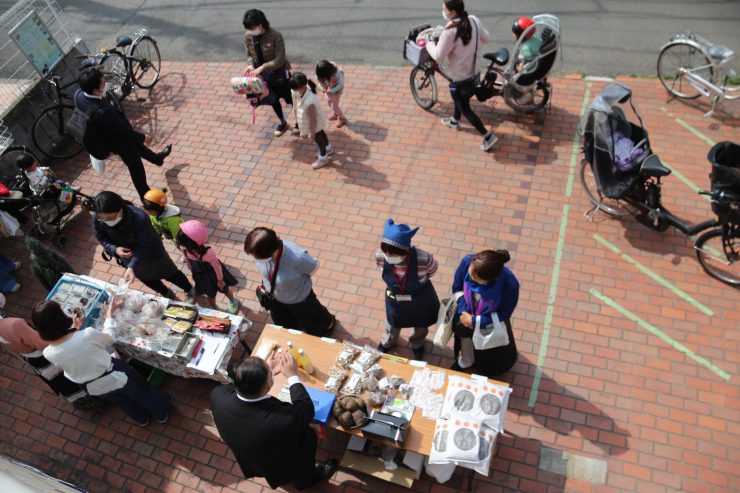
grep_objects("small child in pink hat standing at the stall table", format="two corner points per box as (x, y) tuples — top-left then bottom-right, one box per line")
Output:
(177, 220), (239, 315)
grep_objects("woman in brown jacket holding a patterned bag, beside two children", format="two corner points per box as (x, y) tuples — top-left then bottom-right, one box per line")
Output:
(242, 9), (297, 137)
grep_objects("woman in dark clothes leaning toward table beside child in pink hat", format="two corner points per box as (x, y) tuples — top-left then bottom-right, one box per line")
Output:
(93, 191), (195, 303)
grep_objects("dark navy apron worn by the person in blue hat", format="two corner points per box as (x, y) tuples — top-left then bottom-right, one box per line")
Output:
(383, 247), (439, 329)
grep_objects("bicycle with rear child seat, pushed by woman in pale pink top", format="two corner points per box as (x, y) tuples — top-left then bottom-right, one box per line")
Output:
(403, 14), (560, 114)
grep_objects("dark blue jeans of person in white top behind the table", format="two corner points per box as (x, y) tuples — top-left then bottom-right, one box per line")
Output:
(99, 358), (172, 423)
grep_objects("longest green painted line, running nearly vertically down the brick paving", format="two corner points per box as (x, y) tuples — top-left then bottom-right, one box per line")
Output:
(529, 82), (591, 407)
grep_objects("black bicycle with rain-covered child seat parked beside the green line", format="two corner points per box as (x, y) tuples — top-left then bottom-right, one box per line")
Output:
(580, 84), (740, 287)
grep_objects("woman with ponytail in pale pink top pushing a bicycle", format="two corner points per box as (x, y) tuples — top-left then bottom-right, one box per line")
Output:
(426, 0), (498, 151)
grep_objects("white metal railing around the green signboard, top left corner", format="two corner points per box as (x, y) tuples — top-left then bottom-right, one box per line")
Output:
(0, 0), (79, 117)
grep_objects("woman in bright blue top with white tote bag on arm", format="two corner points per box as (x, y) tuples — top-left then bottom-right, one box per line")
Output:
(452, 250), (519, 376)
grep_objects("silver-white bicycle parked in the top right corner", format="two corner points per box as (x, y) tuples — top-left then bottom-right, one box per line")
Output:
(658, 33), (740, 117)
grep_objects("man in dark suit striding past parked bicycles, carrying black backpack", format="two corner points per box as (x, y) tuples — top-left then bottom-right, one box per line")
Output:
(75, 68), (172, 198)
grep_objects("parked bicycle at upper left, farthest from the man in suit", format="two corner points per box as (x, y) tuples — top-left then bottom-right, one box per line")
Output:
(77, 28), (162, 99)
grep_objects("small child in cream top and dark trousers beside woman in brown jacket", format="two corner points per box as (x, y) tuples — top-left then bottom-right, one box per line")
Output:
(289, 72), (334, 169)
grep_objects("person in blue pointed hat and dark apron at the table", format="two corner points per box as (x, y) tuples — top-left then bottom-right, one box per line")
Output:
(375, 219), (439, 359)
